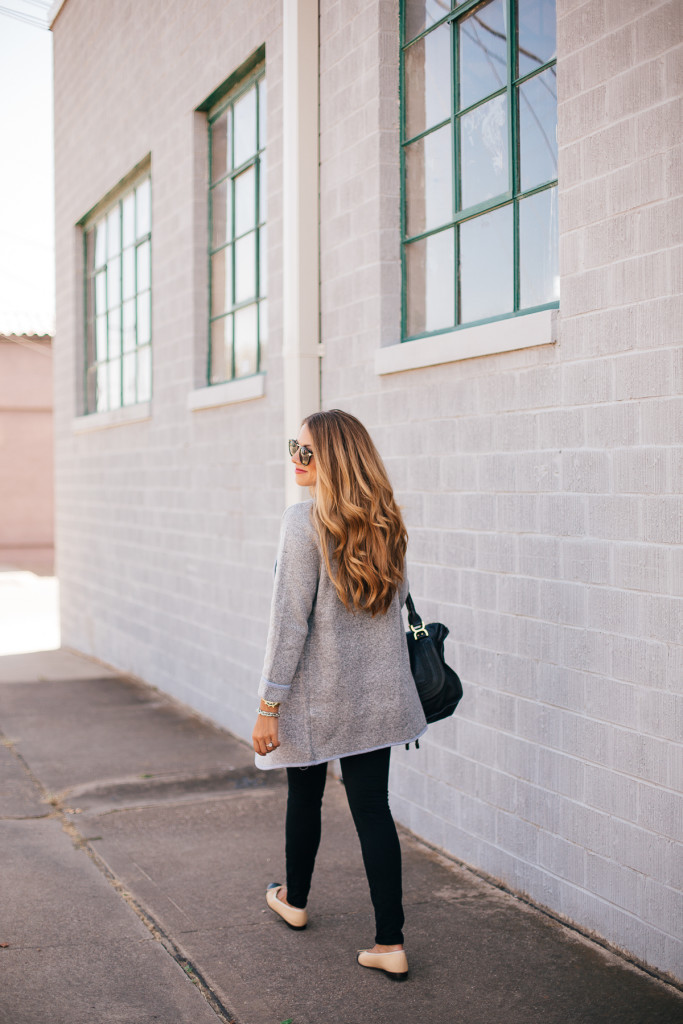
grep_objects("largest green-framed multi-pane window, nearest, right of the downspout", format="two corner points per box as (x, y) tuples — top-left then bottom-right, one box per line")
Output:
(401, 0), (559, 339)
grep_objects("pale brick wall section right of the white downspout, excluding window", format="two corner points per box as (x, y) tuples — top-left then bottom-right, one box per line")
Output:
(321, 0), (683, 975)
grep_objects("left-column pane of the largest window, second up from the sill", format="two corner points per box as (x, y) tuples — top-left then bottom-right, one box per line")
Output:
(405, 125), (453, 234)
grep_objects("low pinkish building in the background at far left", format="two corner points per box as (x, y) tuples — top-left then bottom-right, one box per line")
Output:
(0, 333), (54, 572)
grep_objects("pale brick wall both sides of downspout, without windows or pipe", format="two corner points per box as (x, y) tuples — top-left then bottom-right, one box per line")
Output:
(54, 0), (683, 975)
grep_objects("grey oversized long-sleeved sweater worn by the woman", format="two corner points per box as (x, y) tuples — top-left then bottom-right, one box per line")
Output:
(256, 501), (427, 768)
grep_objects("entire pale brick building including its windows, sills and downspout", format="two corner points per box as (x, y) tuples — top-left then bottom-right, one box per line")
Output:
(52, 0), (683, 978)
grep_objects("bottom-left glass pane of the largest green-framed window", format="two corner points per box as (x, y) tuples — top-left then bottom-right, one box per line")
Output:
(405, 228), (455, 335)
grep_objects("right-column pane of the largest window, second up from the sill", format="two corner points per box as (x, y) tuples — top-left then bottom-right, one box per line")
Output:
(519, 68), (557, 191)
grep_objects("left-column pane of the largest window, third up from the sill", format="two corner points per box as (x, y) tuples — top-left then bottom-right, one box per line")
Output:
(405, 25), (451, 138)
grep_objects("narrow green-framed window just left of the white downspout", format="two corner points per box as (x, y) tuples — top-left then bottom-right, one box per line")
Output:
(209, 67), (268, 384)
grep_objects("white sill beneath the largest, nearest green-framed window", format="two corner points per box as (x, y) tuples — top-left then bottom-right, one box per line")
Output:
(375, 309), (557, 375)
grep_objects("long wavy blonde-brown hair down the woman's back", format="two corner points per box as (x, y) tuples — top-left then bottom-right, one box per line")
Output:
(304, 409), (408, 615)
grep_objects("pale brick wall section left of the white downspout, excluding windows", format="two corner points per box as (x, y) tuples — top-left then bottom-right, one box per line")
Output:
(54, 0), (285, 735)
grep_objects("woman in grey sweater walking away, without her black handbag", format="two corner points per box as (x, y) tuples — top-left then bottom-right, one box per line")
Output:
(253, 410), (427, 981)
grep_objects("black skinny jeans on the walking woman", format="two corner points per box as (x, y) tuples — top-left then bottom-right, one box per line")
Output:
(286, 746), (403, 946)
